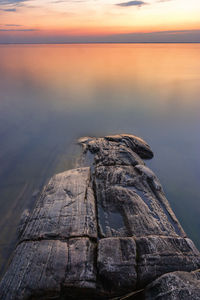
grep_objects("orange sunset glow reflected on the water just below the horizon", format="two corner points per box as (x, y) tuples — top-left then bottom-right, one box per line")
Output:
(0, 44), (200, 110)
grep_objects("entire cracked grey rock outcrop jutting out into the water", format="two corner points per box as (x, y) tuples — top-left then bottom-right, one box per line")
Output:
(0, 134), (200, 300)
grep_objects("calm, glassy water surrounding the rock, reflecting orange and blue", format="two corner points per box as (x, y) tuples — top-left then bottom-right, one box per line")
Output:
(0, 44), (200, 276)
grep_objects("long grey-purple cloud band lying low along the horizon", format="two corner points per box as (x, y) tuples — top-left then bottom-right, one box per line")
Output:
(0, 25), (200, 44)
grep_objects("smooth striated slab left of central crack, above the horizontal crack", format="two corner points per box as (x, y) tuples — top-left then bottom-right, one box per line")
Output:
(20, 168), (97, 241)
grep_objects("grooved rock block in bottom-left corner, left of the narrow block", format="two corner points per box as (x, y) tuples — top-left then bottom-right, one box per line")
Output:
(0, 240), (68, 300)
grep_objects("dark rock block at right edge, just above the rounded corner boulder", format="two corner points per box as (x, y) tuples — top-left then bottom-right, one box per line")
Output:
(136, 236), (200, 287)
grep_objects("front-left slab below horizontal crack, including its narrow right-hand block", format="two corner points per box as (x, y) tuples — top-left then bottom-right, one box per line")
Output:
(0, 238), (96, 300)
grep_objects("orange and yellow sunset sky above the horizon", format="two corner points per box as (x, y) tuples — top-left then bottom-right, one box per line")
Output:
(0, 0), (200, 43)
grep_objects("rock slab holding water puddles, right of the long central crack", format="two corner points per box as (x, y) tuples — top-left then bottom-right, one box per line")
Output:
(94, 166), (185, 237)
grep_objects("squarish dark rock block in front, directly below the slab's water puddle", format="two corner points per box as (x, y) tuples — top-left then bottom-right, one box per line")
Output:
(97, 237), (137, 295)
